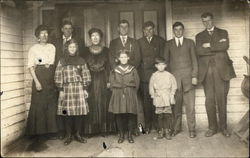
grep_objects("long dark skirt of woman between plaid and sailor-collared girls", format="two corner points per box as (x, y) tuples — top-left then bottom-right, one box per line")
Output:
(84, 71), (116, 134)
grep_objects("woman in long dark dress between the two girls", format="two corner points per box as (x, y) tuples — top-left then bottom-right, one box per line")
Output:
(84, 28), (115, 134)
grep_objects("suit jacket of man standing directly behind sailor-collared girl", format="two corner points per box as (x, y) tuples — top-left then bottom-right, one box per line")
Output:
(109, 37), (141, 69)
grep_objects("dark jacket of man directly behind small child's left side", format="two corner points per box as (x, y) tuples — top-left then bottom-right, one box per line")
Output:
(138, 35), (166, 83)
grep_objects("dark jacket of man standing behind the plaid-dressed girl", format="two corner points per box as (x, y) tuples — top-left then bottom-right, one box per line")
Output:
(52, 35), (85, 65)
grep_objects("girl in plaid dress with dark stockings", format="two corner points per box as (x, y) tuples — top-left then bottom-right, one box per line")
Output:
(55, 39), (91, 145)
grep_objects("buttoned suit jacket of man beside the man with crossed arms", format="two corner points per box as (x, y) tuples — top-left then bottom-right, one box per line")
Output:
(164, 38), (198, 92)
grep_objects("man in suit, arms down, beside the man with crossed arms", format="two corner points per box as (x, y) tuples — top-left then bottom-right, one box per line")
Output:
(164, 22), (198, 138)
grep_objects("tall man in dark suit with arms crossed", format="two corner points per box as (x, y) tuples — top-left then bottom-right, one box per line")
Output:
(195, 13), (236, 137)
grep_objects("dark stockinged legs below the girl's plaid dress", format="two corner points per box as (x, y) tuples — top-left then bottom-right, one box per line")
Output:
(64, 116), (83, 136)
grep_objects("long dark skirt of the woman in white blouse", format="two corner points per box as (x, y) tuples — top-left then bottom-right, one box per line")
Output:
(26, 66), (57, 135)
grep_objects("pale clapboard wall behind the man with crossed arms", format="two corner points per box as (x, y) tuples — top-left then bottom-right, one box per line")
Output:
(171, 0), (249, 126)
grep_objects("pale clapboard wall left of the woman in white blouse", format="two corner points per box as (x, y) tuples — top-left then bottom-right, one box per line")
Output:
(0, 6), (26, 153)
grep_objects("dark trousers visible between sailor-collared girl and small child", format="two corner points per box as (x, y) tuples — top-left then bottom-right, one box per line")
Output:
(140, 83), (159, 129)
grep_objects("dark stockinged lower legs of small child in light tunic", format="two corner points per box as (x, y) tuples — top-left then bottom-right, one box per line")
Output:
(157, 113), (172, 129)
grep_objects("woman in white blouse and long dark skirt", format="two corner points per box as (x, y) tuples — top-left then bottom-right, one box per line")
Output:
(26, 25), (57, 151)
